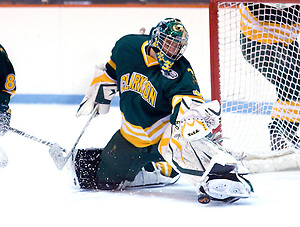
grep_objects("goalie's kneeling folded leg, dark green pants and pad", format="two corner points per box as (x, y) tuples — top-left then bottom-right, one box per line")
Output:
(74, 131), (178, 189)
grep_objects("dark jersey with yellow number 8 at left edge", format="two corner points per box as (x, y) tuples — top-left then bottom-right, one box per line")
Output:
(0, 45), (16, 105)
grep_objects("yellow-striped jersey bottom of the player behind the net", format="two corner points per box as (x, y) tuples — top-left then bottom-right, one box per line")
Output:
(240, 3), (300, 45)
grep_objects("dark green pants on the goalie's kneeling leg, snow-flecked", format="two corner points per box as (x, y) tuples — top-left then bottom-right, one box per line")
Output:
(96, 131), (163, 189)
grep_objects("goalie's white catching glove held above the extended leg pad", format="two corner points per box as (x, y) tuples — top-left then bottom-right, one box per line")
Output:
(178, 100), (221, 141)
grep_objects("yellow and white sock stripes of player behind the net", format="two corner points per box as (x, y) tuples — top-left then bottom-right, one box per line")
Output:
(271, 100), (300, 123)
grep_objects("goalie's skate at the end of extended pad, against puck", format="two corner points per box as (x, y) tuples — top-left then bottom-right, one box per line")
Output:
(198, 163), (253, 204)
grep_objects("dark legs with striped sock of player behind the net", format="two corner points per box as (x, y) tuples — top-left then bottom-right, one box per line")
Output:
(240, 34), (300, 150)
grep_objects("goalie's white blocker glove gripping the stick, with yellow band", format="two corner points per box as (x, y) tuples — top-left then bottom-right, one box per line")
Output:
(76, 65), (118, 117)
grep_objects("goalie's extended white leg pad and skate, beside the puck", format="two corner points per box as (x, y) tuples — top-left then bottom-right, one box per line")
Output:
(159, 124), (253, 204)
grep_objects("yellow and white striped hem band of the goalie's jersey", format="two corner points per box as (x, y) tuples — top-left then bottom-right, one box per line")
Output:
(120, 113), (170, 147)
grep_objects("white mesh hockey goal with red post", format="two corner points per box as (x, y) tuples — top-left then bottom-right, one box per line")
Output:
(209, 0), (300, 172)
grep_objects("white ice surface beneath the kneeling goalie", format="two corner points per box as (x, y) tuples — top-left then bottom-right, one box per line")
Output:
(0, 104), (300, 227)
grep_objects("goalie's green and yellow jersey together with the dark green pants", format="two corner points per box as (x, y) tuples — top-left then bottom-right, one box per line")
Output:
(96, 35), (204, 186)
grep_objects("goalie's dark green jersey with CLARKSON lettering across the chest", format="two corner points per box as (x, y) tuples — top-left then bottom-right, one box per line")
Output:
(106, 35), (204, 147)
